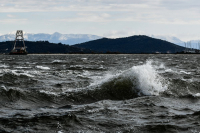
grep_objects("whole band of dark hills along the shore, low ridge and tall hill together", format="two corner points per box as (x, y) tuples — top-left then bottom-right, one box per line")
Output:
(0, 35), (185, 54)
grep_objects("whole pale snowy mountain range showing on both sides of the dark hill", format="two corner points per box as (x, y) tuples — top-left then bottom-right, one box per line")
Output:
(0, 32), (200, 48)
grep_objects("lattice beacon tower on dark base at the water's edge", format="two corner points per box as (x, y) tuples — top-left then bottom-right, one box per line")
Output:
(10, 30), (27, 55)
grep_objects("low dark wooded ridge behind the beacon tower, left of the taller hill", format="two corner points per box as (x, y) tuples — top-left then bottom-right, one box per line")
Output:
(0, 41), (92, 53)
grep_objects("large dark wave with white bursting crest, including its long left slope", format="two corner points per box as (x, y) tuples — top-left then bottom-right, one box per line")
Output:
(59, 61), (168, 102)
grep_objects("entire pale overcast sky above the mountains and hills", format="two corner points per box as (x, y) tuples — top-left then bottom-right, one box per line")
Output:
(0, 0), (200, 41)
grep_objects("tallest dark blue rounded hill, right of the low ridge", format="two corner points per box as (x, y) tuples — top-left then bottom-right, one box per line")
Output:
(73, 35), (185, 53)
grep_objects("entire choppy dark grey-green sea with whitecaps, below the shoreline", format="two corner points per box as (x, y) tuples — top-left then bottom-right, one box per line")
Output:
(0, 55), (200, 133)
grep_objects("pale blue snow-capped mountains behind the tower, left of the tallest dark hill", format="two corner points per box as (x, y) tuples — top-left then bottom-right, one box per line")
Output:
(0, 32), (102, 45)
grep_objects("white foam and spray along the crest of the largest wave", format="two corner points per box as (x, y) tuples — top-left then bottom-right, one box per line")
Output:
(91, 60), (168, 95)
